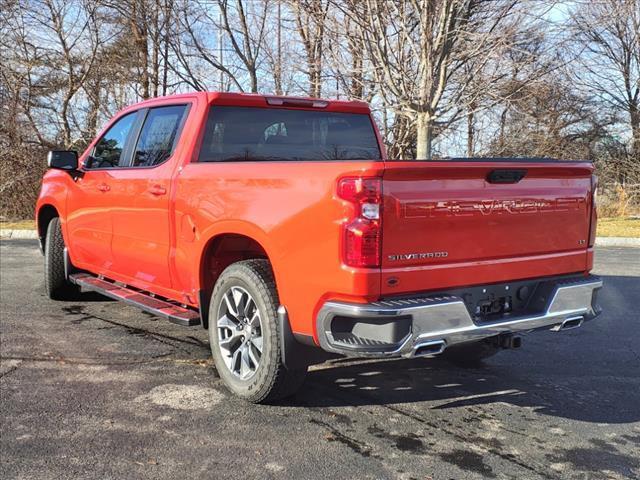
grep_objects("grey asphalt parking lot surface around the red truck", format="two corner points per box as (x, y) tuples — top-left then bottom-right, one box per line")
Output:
(0, 240), (640, 480)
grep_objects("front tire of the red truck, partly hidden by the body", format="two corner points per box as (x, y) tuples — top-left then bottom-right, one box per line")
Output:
(44, 217), (78, 300)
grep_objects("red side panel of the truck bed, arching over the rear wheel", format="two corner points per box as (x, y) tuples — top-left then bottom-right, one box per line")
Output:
(175, 161), (384, 335)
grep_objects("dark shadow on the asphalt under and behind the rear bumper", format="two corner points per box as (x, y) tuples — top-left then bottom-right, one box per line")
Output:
(293, 276), (640, 423)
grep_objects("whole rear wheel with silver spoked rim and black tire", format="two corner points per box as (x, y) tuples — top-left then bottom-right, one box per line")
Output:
(209, 260), (307, 403)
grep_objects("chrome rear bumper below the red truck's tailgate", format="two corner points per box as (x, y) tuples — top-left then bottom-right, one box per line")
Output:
(317, 276), (602, 357)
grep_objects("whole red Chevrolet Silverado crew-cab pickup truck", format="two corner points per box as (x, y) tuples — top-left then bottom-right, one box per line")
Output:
(36, 92), (602, 402)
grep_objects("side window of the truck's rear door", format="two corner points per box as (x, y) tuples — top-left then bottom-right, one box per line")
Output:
(133, 105), (187, 167)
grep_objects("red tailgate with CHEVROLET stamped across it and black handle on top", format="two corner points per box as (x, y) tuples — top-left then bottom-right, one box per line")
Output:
(382, 161), (593, 295)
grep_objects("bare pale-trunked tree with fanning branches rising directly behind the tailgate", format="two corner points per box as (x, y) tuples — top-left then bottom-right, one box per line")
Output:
(346, 0), (518, 158)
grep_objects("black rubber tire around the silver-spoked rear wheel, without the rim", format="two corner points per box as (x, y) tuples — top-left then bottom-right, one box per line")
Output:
(209, 259), (307, 403)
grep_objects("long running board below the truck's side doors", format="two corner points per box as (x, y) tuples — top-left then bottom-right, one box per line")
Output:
(69, 273), (200, 327)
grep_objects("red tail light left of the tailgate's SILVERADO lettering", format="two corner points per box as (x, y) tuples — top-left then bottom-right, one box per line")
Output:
(338, 177), (382, 267)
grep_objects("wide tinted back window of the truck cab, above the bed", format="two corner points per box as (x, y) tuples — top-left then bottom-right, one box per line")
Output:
(199, 107), (380, 162)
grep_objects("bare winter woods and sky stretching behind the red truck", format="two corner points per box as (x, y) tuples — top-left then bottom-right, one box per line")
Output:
(0, 0), (640, 219)
